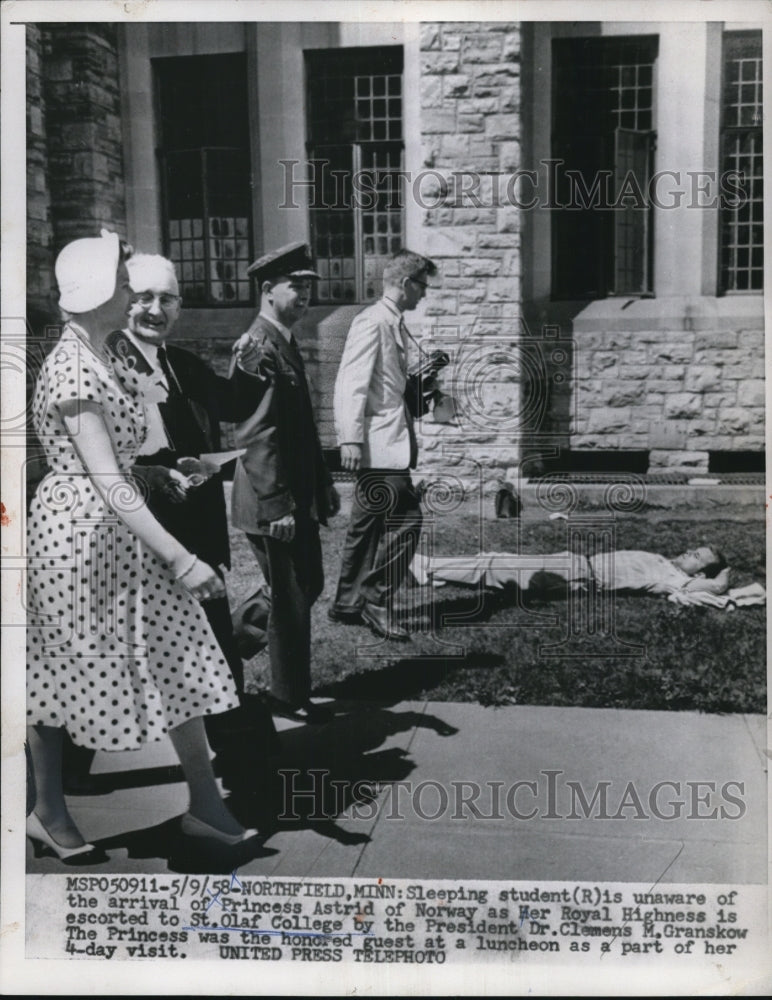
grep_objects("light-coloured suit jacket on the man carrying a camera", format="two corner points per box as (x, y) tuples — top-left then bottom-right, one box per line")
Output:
(334, 299), (415, 469)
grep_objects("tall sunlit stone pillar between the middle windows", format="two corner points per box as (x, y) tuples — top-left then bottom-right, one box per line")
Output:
(416, 22), (521, 482)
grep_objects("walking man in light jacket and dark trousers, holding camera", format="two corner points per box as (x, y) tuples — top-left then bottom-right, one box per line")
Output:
(328, 250), (437, 640)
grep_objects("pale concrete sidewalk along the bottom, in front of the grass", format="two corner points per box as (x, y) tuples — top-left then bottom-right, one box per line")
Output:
(28, 701), (767, 884)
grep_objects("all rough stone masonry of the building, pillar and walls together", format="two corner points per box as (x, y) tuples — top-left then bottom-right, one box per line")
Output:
(27, 22), (764, 476)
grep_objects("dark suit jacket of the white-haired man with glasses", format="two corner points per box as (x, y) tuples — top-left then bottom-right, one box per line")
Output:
(136, 344), (244, 567)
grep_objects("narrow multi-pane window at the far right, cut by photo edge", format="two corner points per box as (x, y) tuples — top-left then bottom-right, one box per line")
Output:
(720, 31), (764, 292)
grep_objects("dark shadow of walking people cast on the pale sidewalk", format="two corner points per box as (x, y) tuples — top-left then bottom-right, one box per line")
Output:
(228, 699), (458, 844)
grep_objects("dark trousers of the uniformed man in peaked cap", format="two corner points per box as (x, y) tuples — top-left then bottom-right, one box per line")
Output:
(247, 513), (324, 707)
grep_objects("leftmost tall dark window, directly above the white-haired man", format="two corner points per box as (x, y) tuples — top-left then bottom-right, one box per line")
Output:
(154, 53), (252, 306)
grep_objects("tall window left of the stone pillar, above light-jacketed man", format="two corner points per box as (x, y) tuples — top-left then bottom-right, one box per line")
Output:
(306, 46), (404, 303)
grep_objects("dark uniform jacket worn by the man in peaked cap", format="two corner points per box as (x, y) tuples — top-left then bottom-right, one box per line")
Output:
(232, 316), (332, 534)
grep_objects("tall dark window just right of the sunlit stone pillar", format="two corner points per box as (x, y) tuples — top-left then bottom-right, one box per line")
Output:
(552, 35), (657, 298)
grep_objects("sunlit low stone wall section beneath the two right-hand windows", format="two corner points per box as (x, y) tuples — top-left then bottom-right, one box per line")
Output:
(570, 316), (764, 472)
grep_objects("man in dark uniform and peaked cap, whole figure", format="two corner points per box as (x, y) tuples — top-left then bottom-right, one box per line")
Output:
(232, 243), (340, 723)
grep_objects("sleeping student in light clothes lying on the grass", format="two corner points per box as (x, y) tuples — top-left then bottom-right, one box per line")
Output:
(410, 545), (729, 594)
